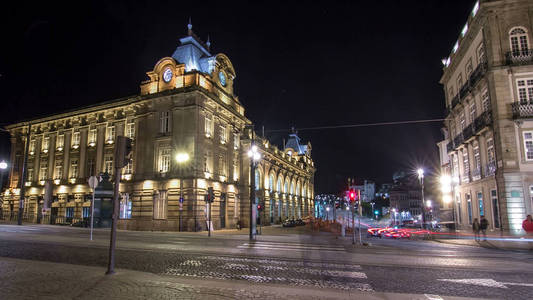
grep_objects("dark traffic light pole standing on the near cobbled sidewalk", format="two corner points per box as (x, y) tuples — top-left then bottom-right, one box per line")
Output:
(106, 136), (132, 275)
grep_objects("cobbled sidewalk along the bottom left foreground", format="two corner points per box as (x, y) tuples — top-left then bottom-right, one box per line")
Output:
(0, 257), (480, 300)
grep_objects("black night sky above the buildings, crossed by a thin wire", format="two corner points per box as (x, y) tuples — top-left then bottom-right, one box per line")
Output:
(0, 0), (474, 193)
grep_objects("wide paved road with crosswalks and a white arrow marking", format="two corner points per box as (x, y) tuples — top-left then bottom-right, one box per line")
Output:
(0, 225), (533, 299)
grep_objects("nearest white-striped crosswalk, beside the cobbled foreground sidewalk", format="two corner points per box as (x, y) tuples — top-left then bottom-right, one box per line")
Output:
(164, 255), (373, 292)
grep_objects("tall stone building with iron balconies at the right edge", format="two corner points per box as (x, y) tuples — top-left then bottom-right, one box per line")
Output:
(439, 0), (533, 234)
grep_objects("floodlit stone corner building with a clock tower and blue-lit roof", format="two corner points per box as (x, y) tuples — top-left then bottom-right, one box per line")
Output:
(2, 24), (315, 231)
